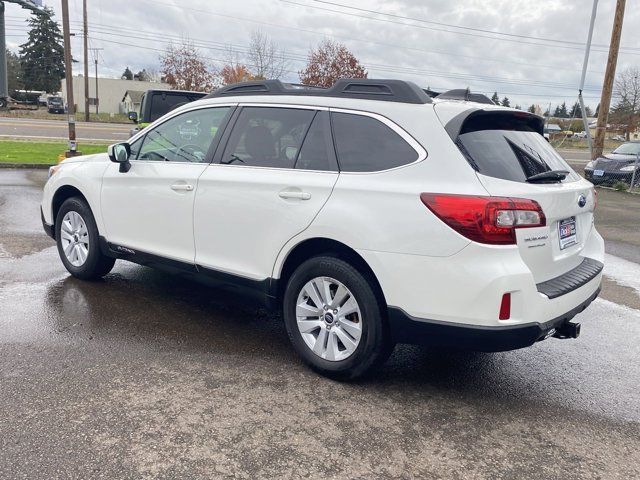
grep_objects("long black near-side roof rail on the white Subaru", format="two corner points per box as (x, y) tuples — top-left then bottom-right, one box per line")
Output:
(205, 78), (431, 104)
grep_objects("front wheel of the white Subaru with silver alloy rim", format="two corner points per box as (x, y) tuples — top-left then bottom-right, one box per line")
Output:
(55, 197), (115, 280)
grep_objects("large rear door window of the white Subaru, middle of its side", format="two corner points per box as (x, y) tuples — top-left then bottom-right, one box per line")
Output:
(221, 107), (316, 168)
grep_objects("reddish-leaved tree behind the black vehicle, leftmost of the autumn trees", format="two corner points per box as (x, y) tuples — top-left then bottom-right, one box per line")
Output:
(160, 41), (217, 92)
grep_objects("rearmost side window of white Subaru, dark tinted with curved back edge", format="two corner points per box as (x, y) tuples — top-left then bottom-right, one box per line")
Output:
(331, 113), (418, 172)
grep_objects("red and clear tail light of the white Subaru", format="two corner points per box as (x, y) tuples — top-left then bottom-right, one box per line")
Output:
(420, 193), (546, 245)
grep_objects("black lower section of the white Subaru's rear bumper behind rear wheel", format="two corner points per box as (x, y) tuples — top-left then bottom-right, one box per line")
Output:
(389, 288), (600, 352)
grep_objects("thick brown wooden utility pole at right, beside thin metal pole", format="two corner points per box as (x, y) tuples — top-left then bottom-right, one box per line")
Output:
(591, 0), (626, 160)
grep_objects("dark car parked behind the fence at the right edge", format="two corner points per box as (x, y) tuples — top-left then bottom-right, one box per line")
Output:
(584, 140), (640, 185)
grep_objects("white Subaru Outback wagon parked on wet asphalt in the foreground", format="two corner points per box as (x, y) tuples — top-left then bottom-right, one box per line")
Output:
(42, 80), (604, 378)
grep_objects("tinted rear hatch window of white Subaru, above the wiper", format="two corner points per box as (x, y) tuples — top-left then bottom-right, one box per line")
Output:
(456, 114), (579, 182)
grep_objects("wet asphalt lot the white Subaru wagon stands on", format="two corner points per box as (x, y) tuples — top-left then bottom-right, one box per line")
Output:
(0, 170), (640, 479)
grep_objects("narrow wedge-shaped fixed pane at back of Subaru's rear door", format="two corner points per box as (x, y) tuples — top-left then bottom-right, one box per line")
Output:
(295, 112), (335, 171)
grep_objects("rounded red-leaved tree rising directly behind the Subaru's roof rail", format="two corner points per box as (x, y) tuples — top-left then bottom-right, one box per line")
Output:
(299, 40), (367, 88)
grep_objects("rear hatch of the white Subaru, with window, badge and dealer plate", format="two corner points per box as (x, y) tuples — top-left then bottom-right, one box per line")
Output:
(446, 108), (596, 284)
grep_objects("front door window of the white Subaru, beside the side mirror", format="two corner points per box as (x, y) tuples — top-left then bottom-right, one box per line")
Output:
(138, 107), (229, 162)
